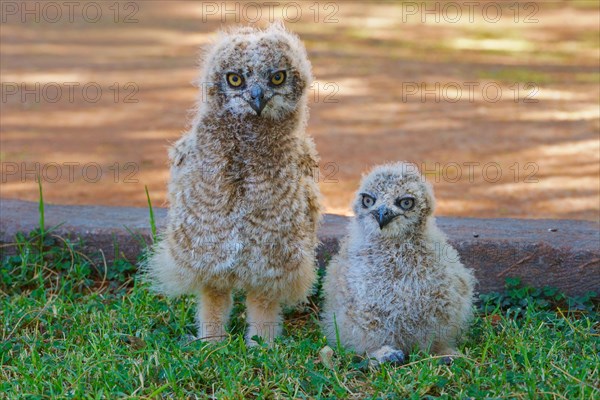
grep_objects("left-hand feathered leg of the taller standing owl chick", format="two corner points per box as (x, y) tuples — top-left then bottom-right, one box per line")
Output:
(196, 288), (233, 342)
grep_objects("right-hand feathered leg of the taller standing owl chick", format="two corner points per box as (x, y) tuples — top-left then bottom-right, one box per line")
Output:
(246, 293), (281, 346)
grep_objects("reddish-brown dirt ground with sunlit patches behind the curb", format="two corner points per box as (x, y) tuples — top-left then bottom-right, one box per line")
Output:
(0, 0), (600, 221)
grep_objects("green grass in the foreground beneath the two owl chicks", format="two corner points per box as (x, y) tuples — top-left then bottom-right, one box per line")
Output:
(0, 229), (600, 399)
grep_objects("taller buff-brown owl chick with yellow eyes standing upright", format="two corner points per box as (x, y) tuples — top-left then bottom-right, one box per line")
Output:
(145, 24), (320, 344)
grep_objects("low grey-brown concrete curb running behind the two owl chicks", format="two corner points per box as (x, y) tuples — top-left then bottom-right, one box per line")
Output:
(0, 199), (600, 295)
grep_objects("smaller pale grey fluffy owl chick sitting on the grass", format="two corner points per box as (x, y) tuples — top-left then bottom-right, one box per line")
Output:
(323, 163), (475, 363)
